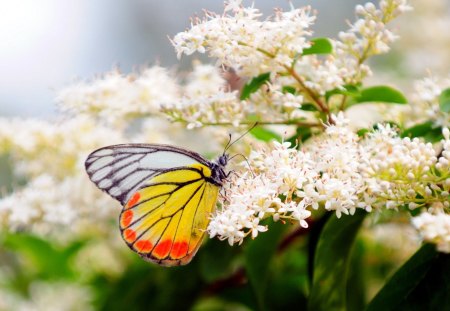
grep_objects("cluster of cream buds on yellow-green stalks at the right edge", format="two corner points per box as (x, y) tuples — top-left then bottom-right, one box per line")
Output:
(364, 127), (450, 209)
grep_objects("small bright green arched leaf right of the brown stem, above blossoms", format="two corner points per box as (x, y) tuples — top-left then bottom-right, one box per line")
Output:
(355, 85), (408, 104)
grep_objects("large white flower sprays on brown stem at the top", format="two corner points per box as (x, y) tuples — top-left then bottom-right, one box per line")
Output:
(163, 0), (410, 128)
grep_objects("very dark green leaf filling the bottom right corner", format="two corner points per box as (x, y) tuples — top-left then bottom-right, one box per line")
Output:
(367, 244), (450, 311)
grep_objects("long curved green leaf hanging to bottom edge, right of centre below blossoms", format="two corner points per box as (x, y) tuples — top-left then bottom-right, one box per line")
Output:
(308, 210), (367, 311)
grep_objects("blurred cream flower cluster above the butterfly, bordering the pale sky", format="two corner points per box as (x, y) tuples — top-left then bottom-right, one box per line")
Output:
(56, 66), (178, 126)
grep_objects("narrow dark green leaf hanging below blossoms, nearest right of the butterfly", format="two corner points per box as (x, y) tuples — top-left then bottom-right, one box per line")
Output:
(244, 222), (286, 310)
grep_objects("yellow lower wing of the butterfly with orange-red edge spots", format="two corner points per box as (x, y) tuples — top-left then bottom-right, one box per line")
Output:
(120, 164), (219, 266)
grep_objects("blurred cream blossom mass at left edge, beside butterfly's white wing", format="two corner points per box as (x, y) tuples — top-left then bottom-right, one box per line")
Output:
(0, 117), (124, 233)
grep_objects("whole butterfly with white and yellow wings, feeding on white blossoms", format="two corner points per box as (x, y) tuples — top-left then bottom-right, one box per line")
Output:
(85, 145), (231, 266)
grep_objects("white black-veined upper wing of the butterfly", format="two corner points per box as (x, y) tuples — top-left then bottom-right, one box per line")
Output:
(85, 144), (208, 205)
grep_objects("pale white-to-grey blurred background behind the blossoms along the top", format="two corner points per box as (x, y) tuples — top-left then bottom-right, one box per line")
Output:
(0, 0), (360, 117)
